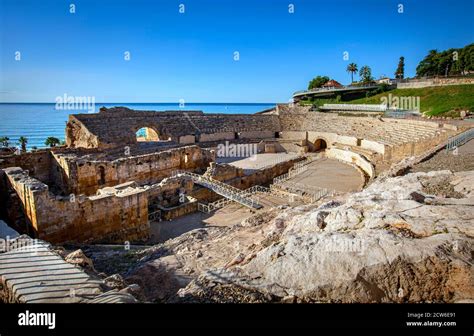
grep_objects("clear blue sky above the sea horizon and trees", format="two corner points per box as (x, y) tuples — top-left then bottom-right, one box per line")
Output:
(0, 0), (474, 102)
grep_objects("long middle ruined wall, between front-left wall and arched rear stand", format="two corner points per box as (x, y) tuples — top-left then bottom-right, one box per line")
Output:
(0, 145), (215, 195)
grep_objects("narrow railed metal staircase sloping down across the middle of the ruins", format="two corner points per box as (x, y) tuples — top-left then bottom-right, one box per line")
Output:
(172, 170), (262, 209)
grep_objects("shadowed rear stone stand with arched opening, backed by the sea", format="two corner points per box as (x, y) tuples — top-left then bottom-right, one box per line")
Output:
(66, 107), (280, 148)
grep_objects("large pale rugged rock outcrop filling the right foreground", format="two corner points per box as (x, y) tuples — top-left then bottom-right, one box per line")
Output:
(180, 171), (474, 302)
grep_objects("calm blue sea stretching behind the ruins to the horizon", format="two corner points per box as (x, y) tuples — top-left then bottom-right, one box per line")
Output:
(0, 103), (276, 149)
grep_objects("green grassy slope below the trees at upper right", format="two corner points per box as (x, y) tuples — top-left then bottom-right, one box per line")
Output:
(351, 84), (474, 115)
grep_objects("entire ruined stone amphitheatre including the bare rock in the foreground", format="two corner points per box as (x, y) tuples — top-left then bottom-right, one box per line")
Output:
(0, 104), (474, 302)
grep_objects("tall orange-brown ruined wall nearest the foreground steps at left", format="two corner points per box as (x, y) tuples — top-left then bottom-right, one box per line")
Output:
(5, 167), (149, 243)
